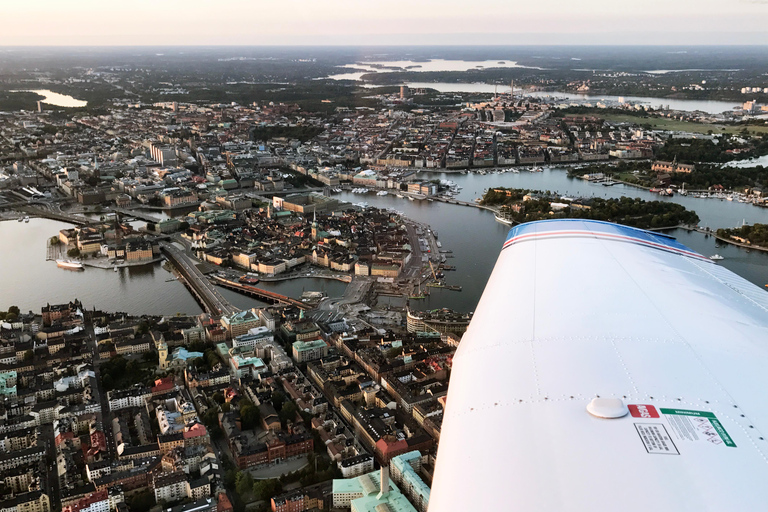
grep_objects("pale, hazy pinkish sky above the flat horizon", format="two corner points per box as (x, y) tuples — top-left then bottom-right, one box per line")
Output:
(0, 0), (768, 46)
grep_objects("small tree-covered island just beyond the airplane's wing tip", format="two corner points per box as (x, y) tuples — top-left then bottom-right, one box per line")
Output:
(480, 188), (699, 229)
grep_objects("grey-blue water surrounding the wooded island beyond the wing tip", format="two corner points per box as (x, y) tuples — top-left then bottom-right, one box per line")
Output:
(335, 169), (768, 311)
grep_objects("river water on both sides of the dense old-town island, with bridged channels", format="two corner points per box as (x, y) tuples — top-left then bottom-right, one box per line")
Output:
(0, 168), (768, 315)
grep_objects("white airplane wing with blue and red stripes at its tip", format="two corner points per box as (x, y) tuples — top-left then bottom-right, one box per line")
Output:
(429, 219), (768, 512)
